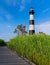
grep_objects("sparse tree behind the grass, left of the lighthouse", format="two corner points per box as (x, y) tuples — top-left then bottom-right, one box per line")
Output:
(14, 24), (27, 35)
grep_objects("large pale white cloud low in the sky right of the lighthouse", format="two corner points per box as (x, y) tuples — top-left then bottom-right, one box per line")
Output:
(35, 21), (50, 34)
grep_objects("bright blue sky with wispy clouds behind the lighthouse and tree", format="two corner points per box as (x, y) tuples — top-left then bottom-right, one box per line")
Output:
(0, 0), (50, 41)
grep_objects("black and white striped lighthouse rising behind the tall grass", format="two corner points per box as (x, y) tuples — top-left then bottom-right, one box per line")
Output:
(29, 8), (35, 35)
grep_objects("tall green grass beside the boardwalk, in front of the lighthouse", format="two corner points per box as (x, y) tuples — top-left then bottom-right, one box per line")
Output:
(7, 34), (50, 65)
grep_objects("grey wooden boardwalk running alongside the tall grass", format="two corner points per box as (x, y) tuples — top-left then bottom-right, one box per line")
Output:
(0, 47), (30, 65)
